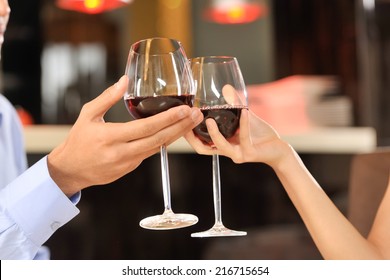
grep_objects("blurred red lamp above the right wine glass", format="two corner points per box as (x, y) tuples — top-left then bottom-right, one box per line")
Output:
(204, 4), (267, 24)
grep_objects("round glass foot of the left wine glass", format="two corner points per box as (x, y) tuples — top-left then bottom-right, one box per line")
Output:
(139, 212), (199, 230)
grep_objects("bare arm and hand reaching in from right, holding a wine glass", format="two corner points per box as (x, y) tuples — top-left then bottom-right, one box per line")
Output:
(186, 110), (390, 259)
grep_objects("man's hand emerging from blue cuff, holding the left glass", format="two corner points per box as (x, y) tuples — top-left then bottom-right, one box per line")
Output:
(48, 76), (203, 196)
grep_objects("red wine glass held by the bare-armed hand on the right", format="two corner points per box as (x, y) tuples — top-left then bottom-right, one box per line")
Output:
(190, 56), (248, 237)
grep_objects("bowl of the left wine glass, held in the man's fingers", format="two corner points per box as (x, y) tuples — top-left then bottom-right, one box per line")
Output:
(124, 38), (194, 119)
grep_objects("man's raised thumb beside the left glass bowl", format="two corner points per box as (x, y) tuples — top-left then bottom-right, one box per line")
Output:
(89, 75), (128, 117)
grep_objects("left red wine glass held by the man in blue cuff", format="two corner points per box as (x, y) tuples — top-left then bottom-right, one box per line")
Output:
(124, 38), (198, 230)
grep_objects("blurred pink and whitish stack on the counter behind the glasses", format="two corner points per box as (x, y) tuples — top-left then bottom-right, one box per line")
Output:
(247, 75), (354, 134)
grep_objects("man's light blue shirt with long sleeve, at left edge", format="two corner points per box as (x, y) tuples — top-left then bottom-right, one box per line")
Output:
(0, 94), (80, 259)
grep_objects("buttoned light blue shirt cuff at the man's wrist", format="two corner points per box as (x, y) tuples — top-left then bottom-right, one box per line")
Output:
(5, 156), (80, 245)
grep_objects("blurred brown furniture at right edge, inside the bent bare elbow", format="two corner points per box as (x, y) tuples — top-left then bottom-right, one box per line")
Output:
(348, 147), (390, 236)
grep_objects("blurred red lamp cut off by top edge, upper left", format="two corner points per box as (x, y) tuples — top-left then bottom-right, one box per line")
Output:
(57, 0), (132, 14)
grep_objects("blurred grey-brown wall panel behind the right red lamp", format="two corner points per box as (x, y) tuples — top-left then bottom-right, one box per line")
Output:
(192, 0), (275, 84)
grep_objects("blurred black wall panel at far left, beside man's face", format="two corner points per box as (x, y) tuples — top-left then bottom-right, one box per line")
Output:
(1, 0), (42, 123)
